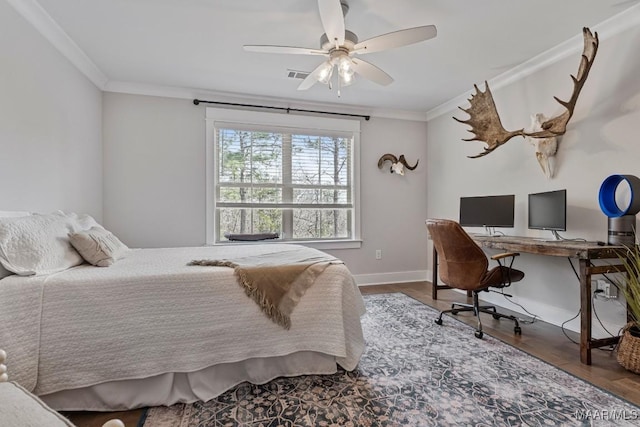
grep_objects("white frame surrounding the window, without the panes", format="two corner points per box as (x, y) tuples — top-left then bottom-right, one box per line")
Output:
(205, 107), (362, 249)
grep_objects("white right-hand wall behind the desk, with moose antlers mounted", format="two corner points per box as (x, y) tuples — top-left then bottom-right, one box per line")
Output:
(427, 24), (640, 335)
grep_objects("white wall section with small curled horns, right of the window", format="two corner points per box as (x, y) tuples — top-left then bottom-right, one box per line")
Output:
(328, 117), (427, 284)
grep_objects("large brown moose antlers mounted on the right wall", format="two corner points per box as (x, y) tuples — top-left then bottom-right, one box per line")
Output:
(454, 27), (599, 174)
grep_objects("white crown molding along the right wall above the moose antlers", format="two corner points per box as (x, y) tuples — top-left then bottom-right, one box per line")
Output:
(426, 4), (640, 121)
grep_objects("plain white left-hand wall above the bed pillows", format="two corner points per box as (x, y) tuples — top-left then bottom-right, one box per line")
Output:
(0, 1), (102, 220)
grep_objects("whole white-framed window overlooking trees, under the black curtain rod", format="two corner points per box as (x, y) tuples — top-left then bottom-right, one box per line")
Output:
(207, 108), (360, 248)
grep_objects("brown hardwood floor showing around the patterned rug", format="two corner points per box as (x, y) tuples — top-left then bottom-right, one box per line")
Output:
(65, 282), (640, 427)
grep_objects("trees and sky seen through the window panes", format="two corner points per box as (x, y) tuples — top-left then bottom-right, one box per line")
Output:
(216, 129), (351, 239)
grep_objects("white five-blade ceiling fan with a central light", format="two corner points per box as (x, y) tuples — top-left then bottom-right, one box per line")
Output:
(244, 0), (437, 96)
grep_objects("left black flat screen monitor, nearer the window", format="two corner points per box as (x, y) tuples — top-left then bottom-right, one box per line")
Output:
(460, 194), (515, 228)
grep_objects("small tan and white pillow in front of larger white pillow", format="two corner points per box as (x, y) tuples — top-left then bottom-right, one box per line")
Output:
(69, 226), (129, 267)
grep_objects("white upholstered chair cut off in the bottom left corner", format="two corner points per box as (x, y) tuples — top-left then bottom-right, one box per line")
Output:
(0, 349), (124, 427)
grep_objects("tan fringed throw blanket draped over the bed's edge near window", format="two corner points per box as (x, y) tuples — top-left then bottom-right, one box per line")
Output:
(188, 248), (342, 329)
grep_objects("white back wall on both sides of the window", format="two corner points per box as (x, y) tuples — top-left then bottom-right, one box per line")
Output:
(103, 93), (427, 283)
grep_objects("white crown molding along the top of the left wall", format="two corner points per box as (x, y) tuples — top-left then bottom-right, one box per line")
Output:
(7, 0), (109, 89)
